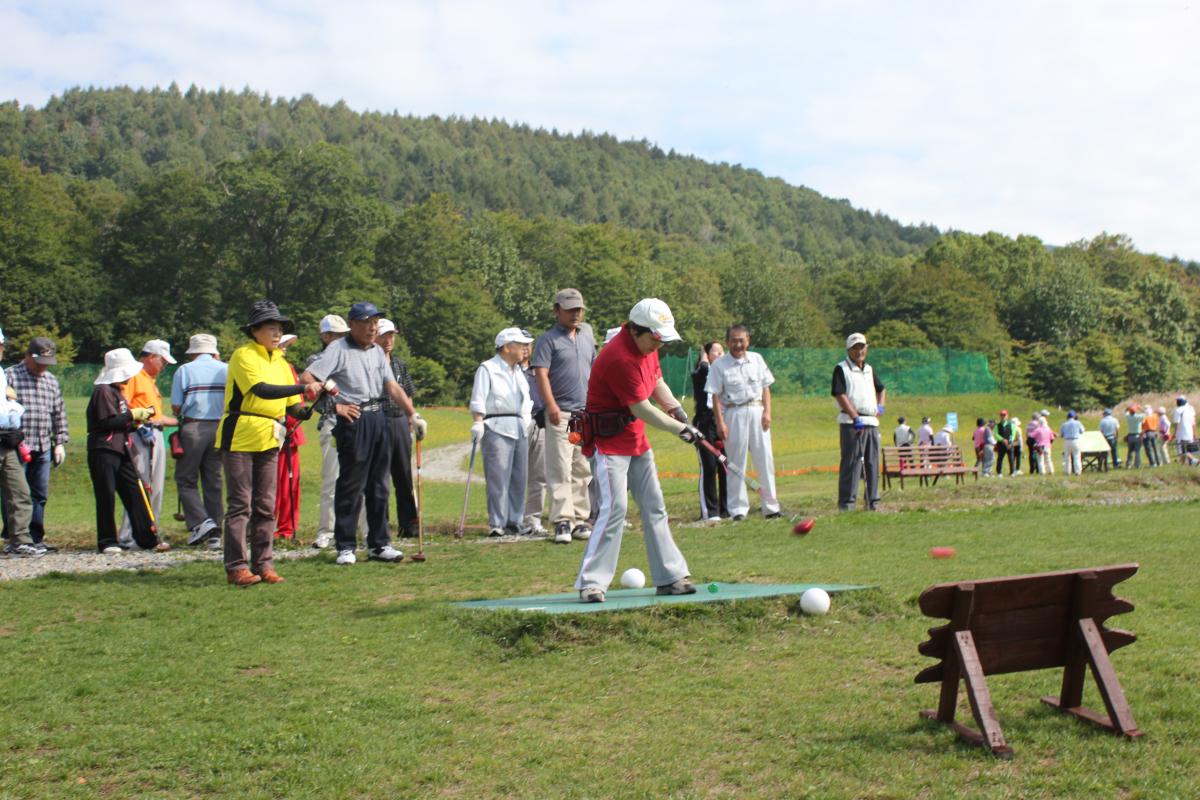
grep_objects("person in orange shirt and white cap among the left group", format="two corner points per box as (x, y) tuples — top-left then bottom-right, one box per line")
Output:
(116, 339), (179, 549)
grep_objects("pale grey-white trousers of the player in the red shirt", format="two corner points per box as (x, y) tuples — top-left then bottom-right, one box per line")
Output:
(575, 450), (690, 591)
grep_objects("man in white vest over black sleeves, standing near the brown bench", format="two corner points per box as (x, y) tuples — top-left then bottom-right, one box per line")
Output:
(832, 333), (884, 511)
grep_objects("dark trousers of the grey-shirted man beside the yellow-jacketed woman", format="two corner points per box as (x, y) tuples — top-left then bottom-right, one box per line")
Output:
(334, 411), (391, 551)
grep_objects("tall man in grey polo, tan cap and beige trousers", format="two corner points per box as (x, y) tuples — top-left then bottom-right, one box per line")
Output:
(529, 289), (596, 545)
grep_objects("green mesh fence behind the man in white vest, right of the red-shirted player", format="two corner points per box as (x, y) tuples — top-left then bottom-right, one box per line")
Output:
(661, 348), (998, 397)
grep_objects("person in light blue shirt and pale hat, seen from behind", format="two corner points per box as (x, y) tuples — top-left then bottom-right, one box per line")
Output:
(170, 333), (228, 551)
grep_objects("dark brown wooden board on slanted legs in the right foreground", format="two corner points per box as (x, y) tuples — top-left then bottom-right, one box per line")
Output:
(916, 564), (1141, 758)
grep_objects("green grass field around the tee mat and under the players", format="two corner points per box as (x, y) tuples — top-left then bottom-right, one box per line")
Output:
(0, 397), (1200, 798)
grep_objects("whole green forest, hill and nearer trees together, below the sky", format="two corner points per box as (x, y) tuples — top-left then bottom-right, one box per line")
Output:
(0, 89), (1200, 405)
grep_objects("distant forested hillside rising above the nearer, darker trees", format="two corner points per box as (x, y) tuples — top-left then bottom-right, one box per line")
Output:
(0, 86), (938, 265)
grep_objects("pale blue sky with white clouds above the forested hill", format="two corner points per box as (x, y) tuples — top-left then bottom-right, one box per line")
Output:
(7, 0), (1200, 259)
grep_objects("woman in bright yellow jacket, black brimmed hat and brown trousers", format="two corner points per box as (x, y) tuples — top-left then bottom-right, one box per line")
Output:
(217, 300), (322, 587)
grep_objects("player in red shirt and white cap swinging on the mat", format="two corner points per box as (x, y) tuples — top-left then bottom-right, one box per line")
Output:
(575, 297), (703, 603)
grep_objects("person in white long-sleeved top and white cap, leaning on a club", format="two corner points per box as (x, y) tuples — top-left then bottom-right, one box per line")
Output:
(470, 327), (533, 536)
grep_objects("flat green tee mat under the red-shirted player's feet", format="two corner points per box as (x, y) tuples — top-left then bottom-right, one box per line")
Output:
(455, 583), (871, 614)
